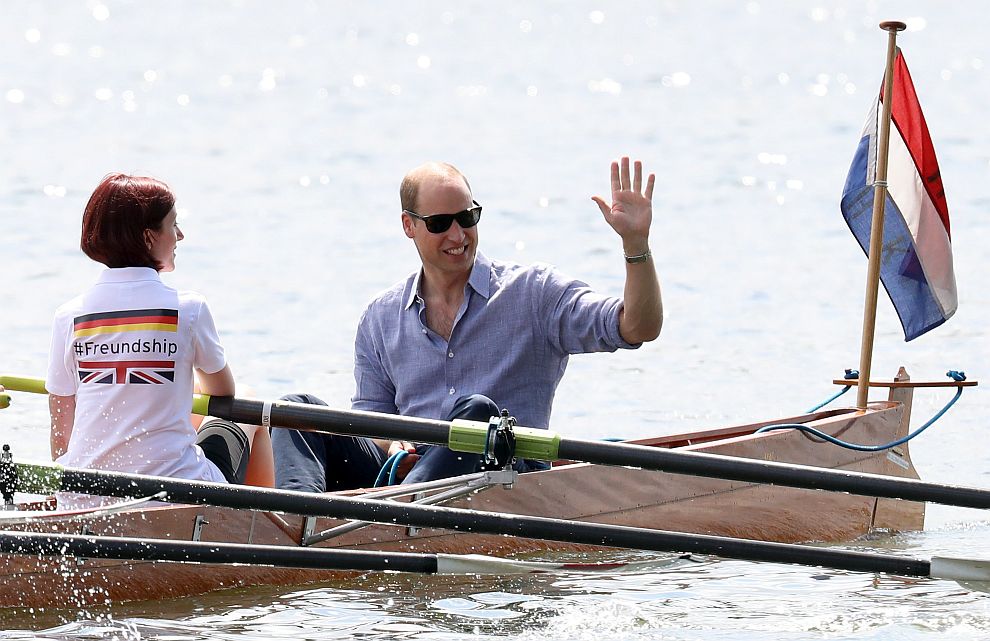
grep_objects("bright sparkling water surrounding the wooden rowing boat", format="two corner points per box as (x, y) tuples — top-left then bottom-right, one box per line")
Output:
(0, 0), (990, 640)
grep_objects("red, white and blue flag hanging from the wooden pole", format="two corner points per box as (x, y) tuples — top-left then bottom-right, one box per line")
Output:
(841, 49), (956, 341)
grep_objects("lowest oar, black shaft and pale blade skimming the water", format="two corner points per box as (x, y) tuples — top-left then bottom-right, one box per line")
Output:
(0, 531), (684, 576)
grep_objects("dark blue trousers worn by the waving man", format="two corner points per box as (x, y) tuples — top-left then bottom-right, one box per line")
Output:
(272, 394), (549, 492)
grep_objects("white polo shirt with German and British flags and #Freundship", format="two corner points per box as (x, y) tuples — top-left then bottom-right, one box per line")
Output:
(45, 267), (226, 483)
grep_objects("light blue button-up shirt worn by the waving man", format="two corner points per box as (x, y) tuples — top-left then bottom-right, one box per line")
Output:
(351, 252), (639, 428)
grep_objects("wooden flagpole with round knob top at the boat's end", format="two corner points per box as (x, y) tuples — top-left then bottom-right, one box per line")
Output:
(856, 20), (907, 410)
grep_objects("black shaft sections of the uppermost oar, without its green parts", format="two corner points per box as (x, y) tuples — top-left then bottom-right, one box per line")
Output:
(209, 397), (990, 509)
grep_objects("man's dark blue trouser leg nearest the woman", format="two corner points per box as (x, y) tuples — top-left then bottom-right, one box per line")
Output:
(272, 394), (385, 492)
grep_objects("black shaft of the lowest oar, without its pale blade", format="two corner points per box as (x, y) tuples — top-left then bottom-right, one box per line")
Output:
(0, 532), (437, 574)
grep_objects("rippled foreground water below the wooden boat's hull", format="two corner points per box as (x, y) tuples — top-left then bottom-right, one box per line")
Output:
(0, 526), (990, 641)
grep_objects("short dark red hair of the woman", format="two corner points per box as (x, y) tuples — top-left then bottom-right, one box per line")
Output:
(79, 174), (175, 270)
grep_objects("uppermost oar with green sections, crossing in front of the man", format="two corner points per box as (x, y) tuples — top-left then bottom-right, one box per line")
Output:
(0, 376), (990, 508)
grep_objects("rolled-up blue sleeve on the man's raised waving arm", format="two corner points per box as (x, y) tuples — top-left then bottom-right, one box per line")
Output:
(534, 266), (641, 354)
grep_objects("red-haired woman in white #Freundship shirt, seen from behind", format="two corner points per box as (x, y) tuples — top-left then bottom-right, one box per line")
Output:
(46, 174), (274, 496)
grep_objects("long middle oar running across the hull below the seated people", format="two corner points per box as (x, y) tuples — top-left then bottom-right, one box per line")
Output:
(7, 463), (990, 581)
